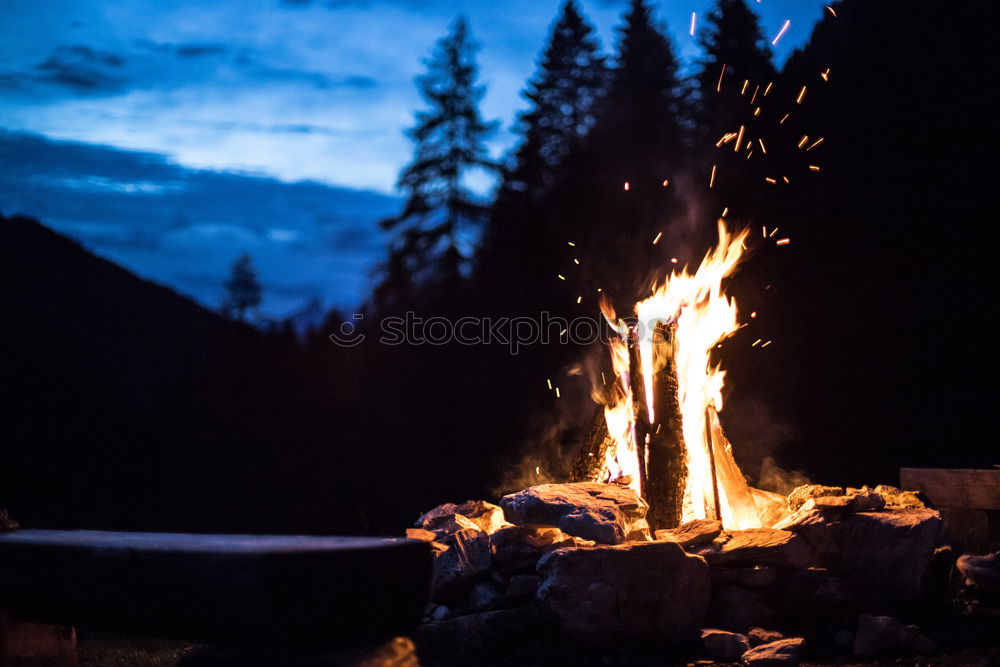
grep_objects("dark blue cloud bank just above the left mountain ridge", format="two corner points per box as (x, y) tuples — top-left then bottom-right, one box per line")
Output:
(0, 130), (399, 314)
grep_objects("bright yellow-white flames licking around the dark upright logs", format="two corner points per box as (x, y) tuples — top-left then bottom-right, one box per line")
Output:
(601, 219), (761, 529)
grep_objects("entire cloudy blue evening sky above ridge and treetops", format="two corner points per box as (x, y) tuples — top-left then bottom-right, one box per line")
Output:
(0, 0), (823, 314)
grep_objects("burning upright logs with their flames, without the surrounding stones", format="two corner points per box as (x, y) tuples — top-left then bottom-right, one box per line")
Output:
(576, 220), (768, 529)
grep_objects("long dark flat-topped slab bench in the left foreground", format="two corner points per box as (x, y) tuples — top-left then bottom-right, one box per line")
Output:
(0, 530), (431, 645)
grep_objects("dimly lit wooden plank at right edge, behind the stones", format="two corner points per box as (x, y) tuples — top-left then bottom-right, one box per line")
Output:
(899, 468), (1000, 510)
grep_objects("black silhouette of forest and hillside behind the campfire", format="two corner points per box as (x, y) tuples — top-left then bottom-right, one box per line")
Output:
(0, 0), (998, 533)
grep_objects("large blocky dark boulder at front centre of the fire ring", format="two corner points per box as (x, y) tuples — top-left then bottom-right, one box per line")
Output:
(538, 542), (710, 642)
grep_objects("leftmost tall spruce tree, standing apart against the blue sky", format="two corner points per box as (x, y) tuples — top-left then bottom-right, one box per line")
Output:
(375, 17), (496, 308)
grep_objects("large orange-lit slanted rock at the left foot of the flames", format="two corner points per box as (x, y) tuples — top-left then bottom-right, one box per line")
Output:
(500, 482), (648, 544)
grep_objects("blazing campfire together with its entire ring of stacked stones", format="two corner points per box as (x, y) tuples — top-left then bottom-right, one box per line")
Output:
(407, 226), (941, 665)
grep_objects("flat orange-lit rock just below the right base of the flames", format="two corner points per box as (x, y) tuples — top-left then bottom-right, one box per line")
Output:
(698, 528), (814, 568)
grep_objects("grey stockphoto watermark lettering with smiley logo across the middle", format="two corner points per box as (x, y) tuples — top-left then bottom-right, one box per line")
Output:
(329, 312), (672, 354)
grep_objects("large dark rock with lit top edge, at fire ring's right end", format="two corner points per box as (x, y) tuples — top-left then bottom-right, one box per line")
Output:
(829, 509), (941, 613)
